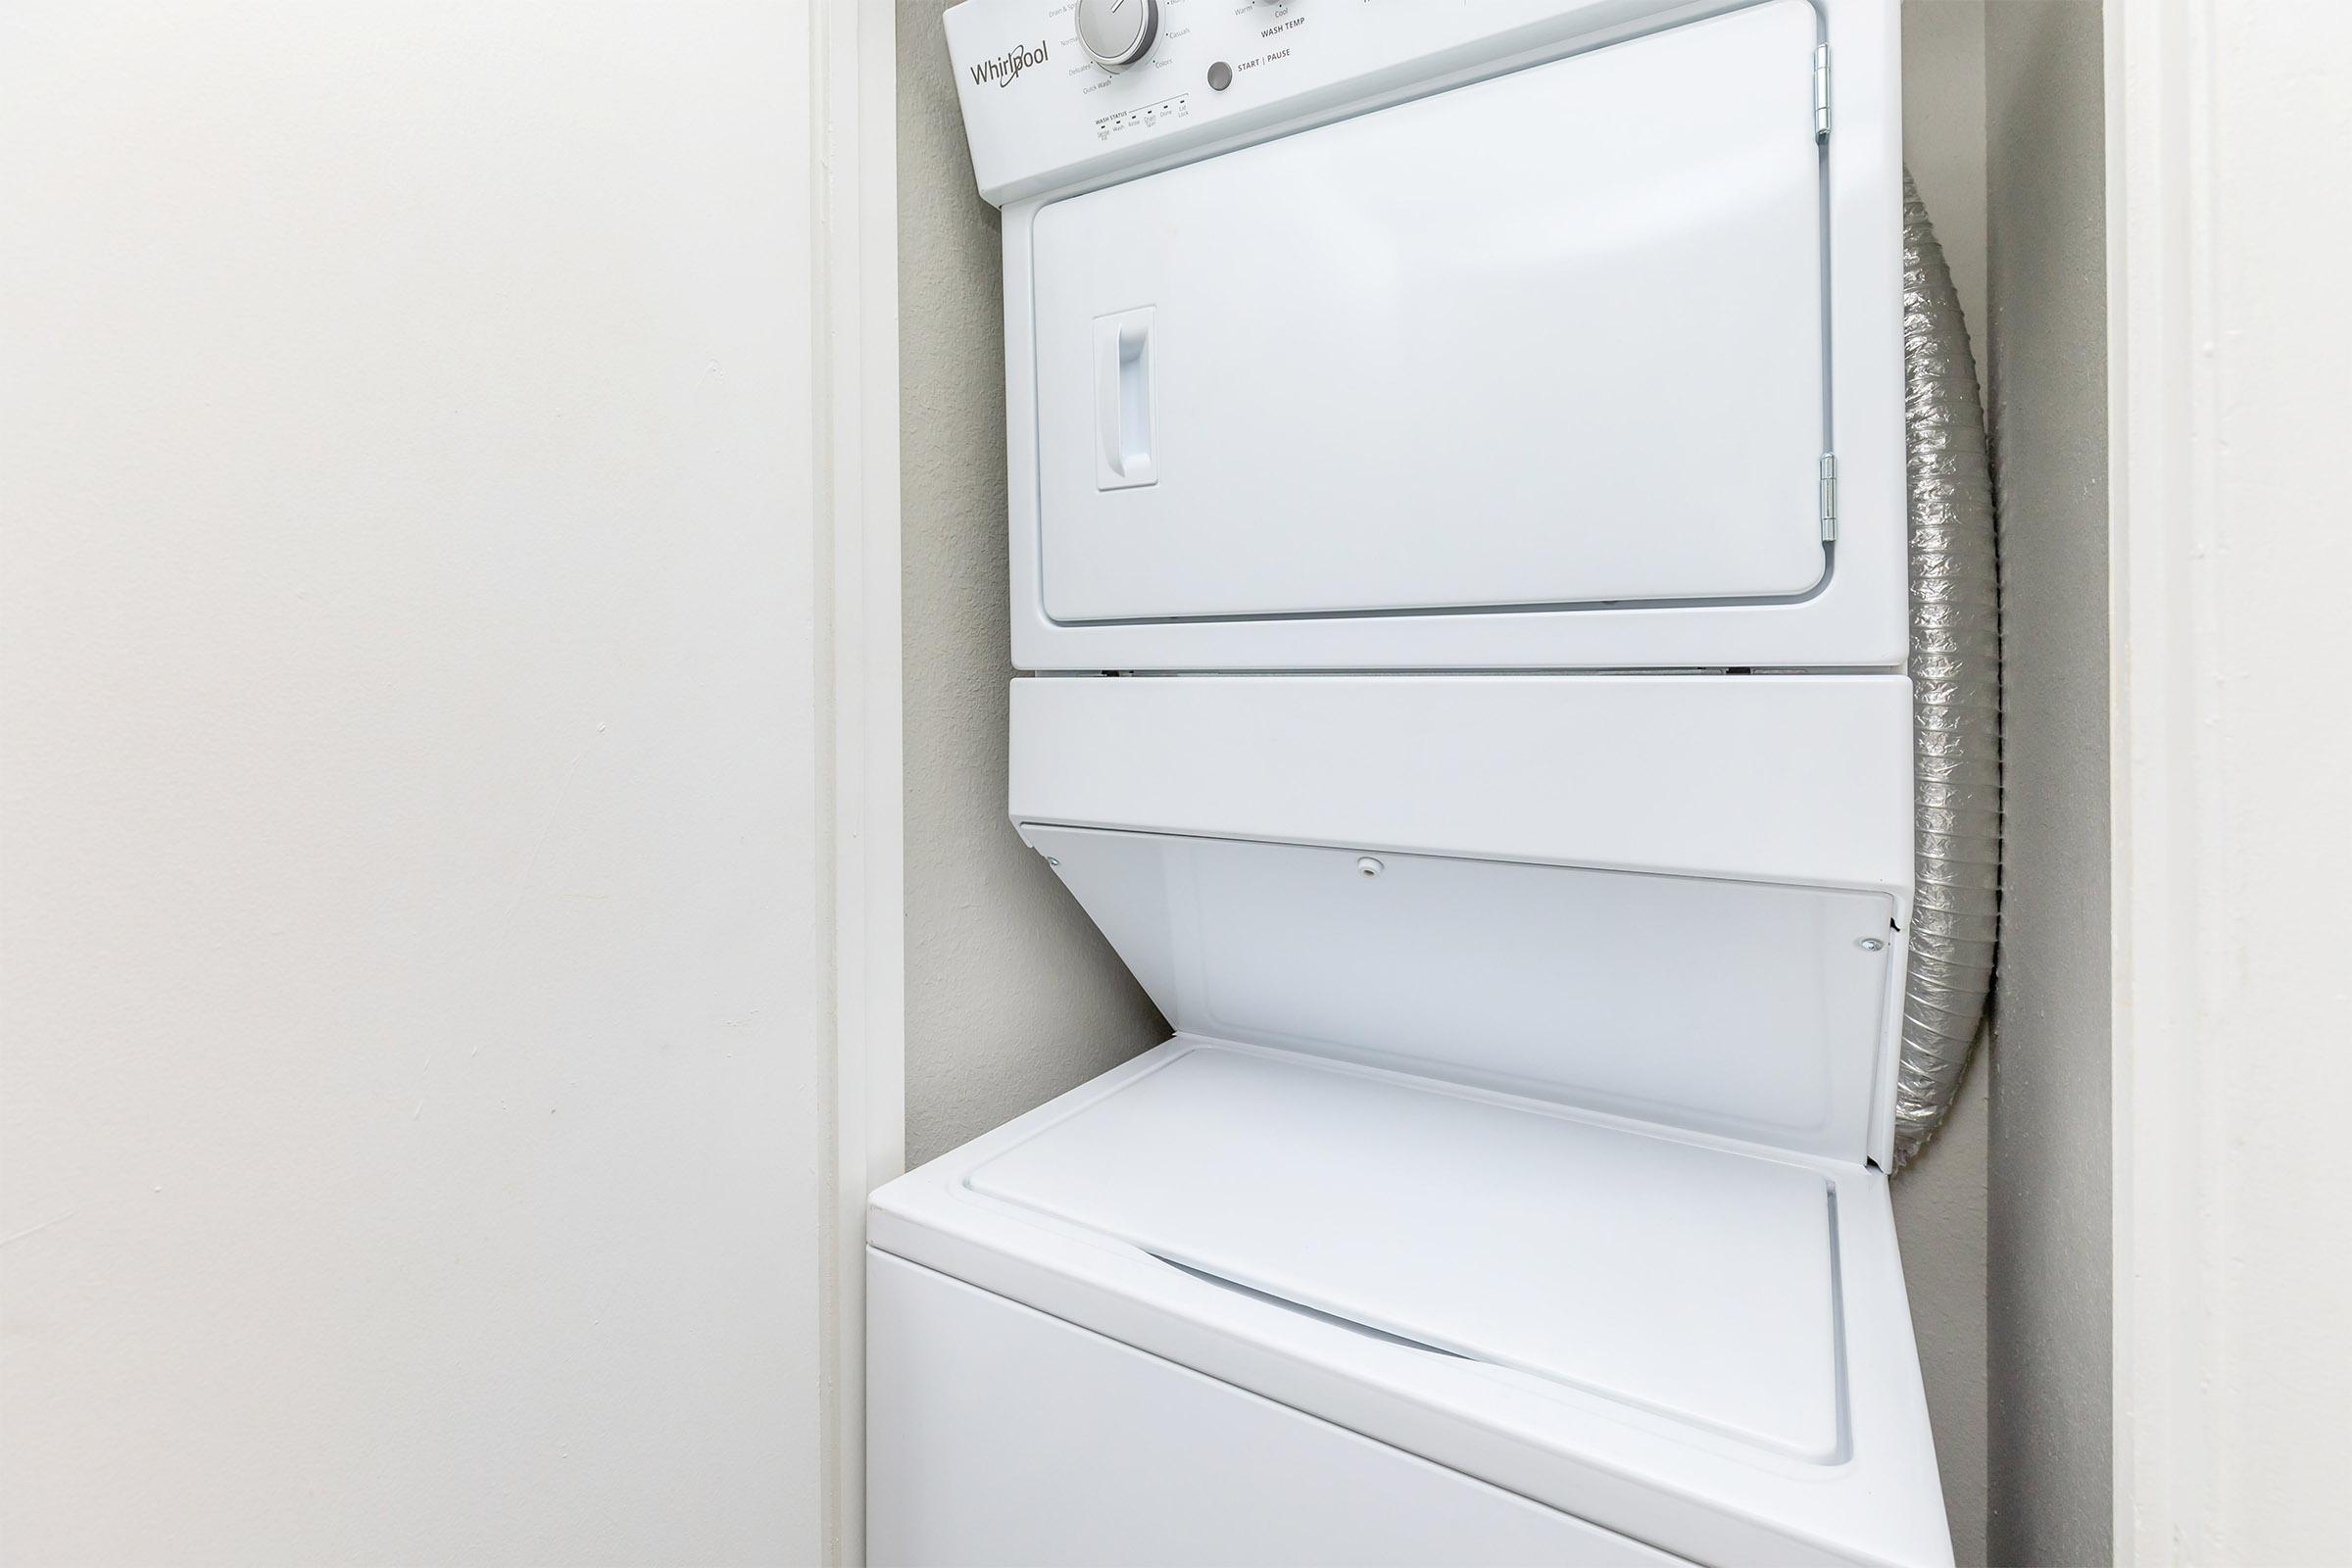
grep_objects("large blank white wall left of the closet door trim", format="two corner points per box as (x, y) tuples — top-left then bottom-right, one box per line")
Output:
(0, 0), (828, 1563)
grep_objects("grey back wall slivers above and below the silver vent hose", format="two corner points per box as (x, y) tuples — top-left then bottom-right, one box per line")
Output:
(1893, 0), (1992, 1568)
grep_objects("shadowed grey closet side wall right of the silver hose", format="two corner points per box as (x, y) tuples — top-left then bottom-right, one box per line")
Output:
(1985, 0), (2112, 1566)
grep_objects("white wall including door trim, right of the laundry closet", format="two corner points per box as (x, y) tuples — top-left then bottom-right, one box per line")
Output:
(2107, 0), (2352, 1563)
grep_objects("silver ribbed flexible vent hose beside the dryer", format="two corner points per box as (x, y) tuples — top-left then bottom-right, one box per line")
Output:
(1895, 172), (2001, 1171)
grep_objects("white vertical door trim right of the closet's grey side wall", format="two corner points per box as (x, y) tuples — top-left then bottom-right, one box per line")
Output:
(2105, 0), (2218, 1563)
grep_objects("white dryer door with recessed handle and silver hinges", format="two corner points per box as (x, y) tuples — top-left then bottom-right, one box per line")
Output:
(1033, 0), (1828, 623)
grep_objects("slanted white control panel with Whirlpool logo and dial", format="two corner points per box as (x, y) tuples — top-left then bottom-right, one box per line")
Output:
(946, 0), (1752, 205)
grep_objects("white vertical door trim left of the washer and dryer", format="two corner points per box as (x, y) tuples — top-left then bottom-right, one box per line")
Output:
(809, 0), (906, 1563)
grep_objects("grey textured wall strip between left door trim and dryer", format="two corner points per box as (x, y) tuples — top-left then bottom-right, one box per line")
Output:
(899, 0), (1166, 1163)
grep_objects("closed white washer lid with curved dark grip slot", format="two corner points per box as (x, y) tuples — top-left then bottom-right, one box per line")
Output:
(966, 1046), (1844, 1462)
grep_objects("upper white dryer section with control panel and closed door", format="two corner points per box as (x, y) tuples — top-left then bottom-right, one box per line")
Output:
(948, 0), (1905, 670)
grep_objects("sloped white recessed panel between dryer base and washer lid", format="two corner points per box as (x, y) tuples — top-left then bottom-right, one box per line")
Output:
(1021, 823), (1895, 1161)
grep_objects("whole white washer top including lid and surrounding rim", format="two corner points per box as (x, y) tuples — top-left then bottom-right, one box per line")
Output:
(868, 1034), (1952, 1568)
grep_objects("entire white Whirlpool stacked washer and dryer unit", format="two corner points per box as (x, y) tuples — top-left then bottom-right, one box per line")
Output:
(868, 0), (1950, 1563)
